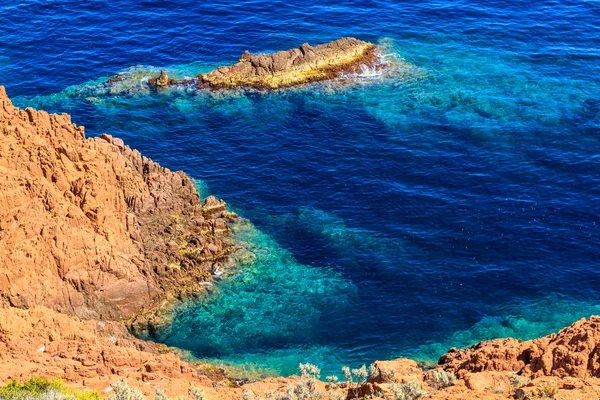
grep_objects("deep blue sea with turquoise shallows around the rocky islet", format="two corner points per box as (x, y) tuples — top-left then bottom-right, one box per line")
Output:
(0, 0), (600, 375)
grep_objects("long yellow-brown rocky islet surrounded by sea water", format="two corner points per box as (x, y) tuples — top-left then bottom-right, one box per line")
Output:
(141, 38), (378, 89)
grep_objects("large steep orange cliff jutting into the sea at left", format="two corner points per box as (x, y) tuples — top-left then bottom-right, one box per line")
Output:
(0, 87), (238, 329)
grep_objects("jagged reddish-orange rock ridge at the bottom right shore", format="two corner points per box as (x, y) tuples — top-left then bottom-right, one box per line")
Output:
(439, 316), (600, 378)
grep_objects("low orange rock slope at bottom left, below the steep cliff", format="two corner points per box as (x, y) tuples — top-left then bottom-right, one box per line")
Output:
(0, 307), (241, 399)
